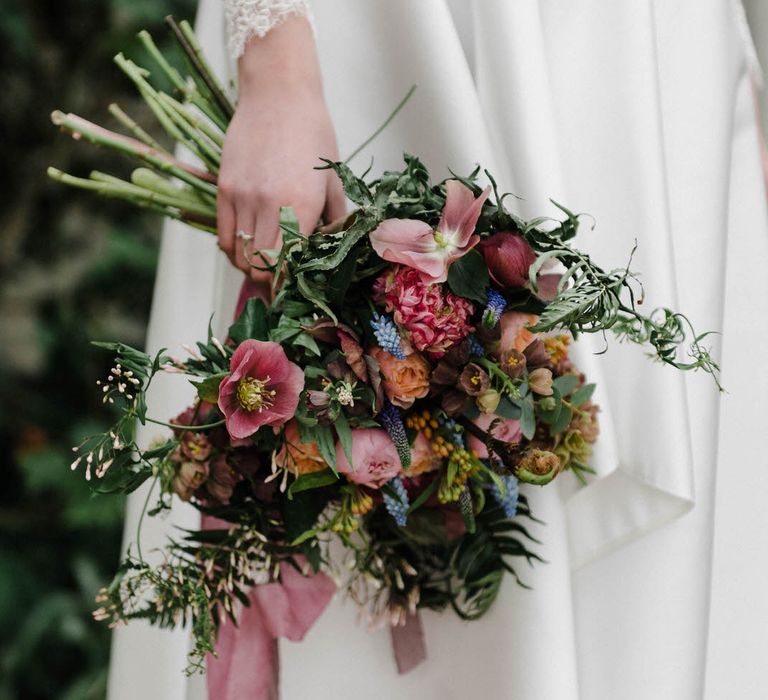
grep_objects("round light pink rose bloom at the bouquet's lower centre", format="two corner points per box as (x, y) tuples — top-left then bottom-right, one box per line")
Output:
(336, 428), (402, 489)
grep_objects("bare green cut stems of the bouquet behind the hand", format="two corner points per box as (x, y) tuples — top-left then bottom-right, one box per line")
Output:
(48, 17), (225, 233)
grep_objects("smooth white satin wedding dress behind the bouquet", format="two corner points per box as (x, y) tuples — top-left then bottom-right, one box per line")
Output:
(109, 0), (768, 700)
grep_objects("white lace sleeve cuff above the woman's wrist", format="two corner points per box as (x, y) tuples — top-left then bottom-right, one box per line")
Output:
(224, 0), (312, 59)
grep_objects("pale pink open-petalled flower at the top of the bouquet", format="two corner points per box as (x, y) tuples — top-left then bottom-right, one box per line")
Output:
(370, 180), (491, 282)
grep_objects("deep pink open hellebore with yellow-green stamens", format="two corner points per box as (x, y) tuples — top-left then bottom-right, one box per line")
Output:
(219, 340), (304, 438)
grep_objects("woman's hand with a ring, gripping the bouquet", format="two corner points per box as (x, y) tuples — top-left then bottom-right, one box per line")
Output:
(217, 17), (345, 281)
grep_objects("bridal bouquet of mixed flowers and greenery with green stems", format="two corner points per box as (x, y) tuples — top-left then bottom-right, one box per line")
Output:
(51, 16), (717, 664)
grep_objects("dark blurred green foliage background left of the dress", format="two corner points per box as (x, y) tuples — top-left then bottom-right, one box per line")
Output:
(0, 0), (196, 700)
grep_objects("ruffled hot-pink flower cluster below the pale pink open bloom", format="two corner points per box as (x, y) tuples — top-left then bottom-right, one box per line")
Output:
(374, 266), (475, 356)
